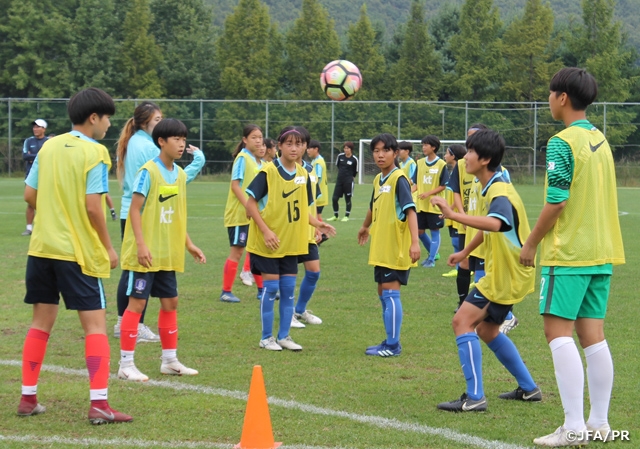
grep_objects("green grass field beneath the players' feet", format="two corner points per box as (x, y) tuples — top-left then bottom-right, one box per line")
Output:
(0, 179), (640, 449)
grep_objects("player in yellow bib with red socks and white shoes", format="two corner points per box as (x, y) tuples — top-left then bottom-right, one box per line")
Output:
(118, 119), (206, 382)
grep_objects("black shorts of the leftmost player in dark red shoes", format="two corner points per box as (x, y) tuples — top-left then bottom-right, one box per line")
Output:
(24, 256), (107, 310)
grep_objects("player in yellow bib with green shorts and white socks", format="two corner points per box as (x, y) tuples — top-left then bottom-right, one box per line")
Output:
(520, 67), (625, 447)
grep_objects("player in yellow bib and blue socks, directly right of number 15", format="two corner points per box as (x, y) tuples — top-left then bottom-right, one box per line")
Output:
(358, 133), (420, 357)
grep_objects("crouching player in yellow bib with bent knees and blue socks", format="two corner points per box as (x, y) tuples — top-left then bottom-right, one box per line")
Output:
(431, 130), (542, 412)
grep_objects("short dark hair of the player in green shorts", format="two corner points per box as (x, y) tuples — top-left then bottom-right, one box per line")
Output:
(549, 67), (598, 111)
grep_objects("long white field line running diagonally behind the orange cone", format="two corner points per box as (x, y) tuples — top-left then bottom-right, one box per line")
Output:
(0, 360), (525, 449)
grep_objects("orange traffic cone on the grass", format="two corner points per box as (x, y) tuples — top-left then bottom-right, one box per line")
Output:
(234, 365), (282, 449)
